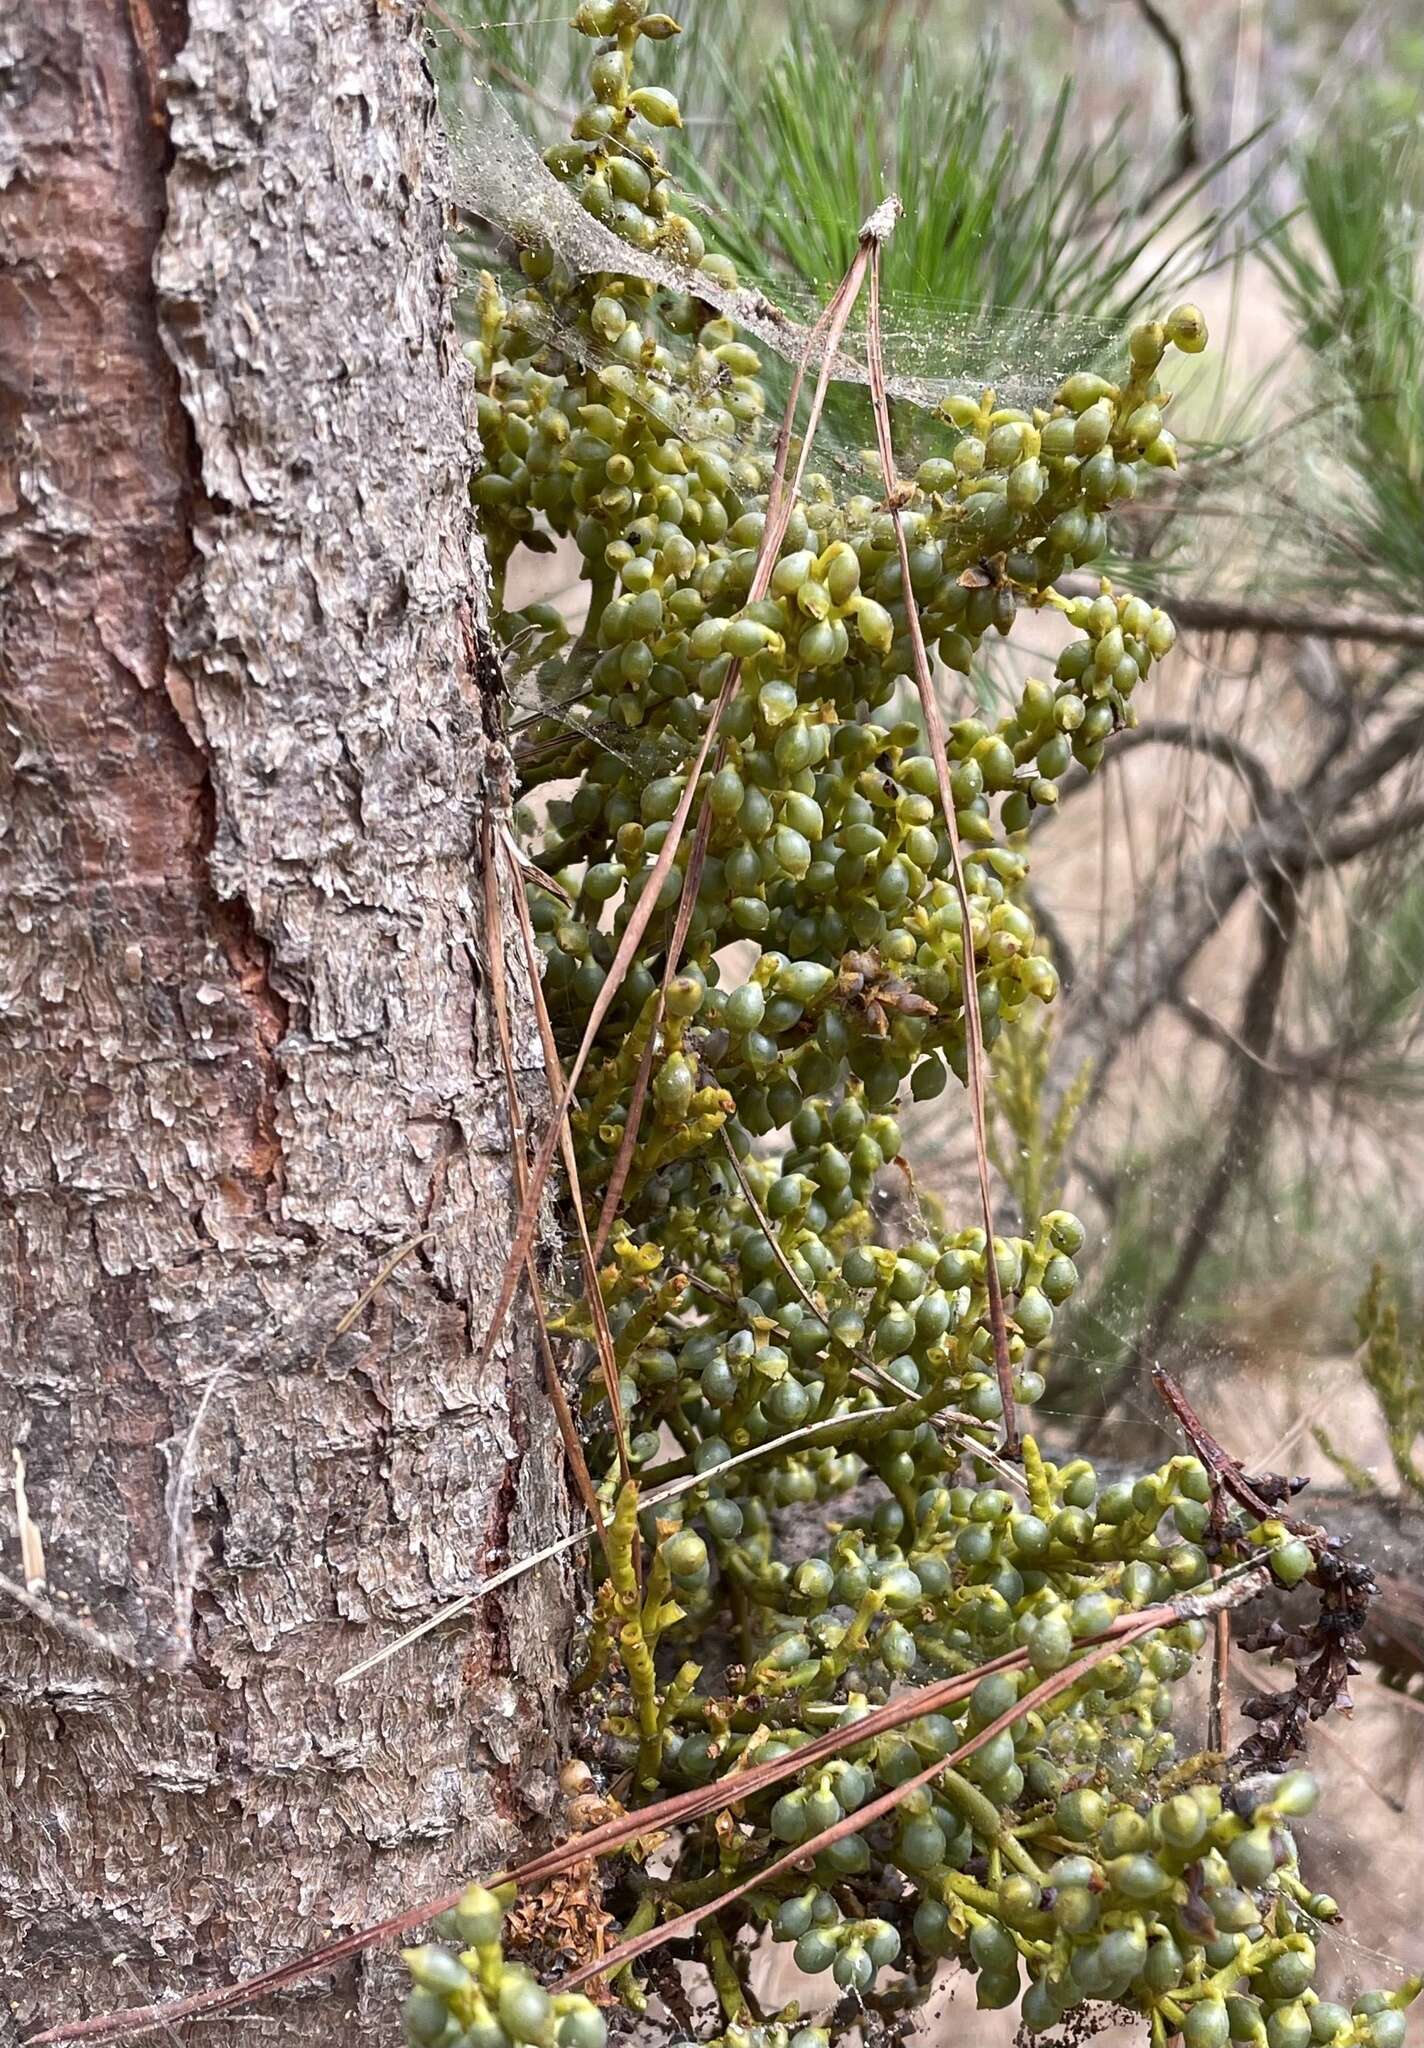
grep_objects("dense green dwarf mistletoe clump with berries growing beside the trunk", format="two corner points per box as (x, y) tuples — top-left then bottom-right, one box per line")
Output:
(406, 0), (1412, 2048)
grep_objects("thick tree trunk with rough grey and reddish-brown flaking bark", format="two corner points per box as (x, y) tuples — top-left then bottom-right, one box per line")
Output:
(0, 0), (568, 2048)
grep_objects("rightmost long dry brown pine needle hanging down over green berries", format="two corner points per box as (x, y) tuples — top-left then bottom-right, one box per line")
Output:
(867, 244), (1020, 1458)
